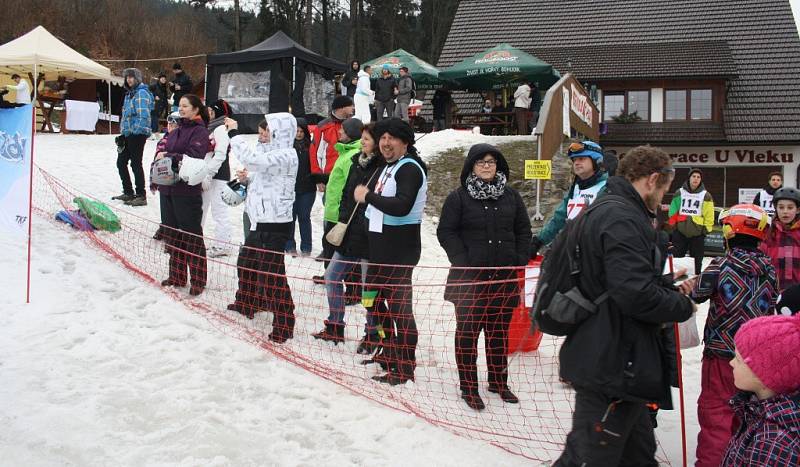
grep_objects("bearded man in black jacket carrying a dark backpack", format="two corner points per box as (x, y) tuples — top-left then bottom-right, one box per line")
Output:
(534, 146), (695, 466)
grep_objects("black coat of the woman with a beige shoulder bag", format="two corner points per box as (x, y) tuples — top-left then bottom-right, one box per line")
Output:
(336, 154), (386, 259)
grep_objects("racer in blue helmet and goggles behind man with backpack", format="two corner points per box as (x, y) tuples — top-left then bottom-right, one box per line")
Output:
(531, 141), (608, 256)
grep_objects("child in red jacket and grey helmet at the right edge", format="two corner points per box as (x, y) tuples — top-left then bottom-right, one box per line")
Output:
(761, 187), (800, 290)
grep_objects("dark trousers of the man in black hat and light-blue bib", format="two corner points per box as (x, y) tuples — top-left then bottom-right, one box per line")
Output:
(365, 265), (419, 378)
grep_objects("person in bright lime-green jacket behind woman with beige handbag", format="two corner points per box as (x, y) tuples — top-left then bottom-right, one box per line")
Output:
(313, 118), (364, 284)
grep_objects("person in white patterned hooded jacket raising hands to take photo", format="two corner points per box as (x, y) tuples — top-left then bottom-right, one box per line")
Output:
(225, 112), (298, 344)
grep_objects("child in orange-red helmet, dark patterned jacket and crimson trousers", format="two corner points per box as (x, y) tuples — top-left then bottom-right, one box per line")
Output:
(691, 204), (778, 467)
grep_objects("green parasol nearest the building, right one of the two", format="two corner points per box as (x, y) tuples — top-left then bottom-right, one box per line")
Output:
(440, 43), (561, 91)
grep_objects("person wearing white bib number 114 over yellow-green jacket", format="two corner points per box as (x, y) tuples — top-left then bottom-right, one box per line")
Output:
(668, 169), (714, 274)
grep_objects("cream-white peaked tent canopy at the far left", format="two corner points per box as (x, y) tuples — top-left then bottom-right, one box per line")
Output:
(0, 26), (122, 84)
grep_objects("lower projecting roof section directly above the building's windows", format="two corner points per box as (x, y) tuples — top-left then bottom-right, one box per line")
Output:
(533, 41), (737, 81)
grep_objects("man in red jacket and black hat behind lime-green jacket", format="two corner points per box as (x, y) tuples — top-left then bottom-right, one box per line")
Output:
(308, 96), (355, 193)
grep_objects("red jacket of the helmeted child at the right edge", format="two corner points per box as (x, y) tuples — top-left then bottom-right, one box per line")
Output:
(761, 219), (800, 290)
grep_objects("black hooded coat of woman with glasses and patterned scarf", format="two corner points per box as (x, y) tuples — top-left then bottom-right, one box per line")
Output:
(436, 144), (531, 308)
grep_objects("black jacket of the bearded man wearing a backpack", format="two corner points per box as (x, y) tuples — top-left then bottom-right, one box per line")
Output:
(560, 177), (693, 405)
